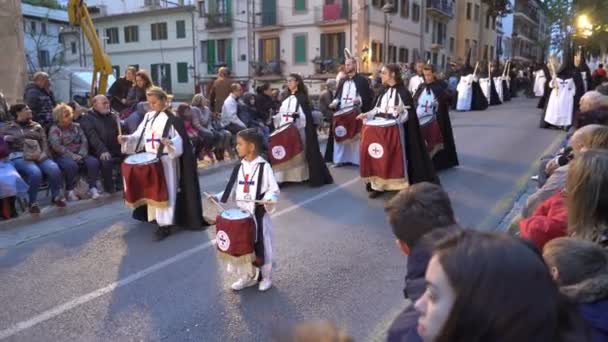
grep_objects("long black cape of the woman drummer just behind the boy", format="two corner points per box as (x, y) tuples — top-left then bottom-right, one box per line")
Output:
(294, 91), (334, 187)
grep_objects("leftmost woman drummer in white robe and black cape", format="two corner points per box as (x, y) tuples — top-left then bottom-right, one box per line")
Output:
(118, 87), (207, 239)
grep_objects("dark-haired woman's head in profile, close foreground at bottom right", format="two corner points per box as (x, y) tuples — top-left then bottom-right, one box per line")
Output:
(415, 230), (589, 342)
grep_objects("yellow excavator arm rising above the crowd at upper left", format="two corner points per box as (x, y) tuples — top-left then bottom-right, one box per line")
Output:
(68, 0), (112, 100)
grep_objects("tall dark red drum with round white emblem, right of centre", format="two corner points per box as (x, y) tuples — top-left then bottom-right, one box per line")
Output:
(360, 118), (408, 191)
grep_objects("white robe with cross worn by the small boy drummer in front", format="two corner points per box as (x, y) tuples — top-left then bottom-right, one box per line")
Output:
(216, 157), (281, 278)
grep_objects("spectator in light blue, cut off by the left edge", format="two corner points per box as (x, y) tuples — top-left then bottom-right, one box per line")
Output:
(0, 136), (28, 220)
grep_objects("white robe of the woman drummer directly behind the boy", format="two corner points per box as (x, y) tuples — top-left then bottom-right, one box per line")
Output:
(274, 95), (310, 183)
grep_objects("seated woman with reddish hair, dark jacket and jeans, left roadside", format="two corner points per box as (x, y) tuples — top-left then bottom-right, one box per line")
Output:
(49, 103), (99, 201)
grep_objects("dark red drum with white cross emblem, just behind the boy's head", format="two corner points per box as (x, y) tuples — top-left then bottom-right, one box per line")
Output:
(268, 124), (305, 170)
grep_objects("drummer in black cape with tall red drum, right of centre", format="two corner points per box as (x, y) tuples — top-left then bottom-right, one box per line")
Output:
(358, 64), (439, 198)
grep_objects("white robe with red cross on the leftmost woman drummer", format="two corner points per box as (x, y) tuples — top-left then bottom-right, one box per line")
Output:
(122, 112), (183, 226)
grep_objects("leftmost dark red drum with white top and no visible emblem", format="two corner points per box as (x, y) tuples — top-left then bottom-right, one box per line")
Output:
(121, 152), (169, 208)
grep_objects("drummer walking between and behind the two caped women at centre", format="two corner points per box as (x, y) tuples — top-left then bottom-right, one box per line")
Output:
(325, 56), (373, 166)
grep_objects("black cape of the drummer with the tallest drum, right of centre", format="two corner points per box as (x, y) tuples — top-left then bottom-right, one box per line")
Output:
(374, 83), (440, 184)
